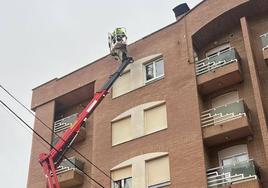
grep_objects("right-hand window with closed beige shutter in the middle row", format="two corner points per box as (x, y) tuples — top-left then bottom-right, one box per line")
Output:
(144, 104), (167, 135)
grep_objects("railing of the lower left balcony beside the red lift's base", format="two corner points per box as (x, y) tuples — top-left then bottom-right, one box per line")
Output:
(56, 157), (84, 175)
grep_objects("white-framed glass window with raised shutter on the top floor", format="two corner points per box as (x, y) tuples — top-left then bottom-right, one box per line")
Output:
(144, 59), (164, 82)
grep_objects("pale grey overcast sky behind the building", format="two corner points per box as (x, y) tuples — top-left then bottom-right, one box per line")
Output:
(0, 0), (201, 188)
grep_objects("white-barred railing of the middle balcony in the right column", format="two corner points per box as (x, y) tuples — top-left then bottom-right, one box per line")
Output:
(201, 99), (248, 127)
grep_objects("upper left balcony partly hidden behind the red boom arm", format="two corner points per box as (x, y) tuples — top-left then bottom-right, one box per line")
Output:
(52, 114), (86, 145)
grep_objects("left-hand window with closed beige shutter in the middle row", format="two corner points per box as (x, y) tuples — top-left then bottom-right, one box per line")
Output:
(112, 116), (132, 145)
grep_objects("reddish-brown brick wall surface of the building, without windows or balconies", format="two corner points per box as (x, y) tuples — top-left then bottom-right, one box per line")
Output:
(28, 0), (268, 188)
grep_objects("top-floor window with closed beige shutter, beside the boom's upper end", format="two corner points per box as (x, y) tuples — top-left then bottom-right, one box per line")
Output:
(112, 71), (131, 97)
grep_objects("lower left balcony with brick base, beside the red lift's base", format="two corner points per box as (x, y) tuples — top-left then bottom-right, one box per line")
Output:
(56, 157), (84, 188)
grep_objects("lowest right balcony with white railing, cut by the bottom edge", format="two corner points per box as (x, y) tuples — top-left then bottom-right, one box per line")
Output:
(207, 160), (261, 188)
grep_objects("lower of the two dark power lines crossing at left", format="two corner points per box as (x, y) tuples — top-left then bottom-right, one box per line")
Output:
(0, 100), (105, 188)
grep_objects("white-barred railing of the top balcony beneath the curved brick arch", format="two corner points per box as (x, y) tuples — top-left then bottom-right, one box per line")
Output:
(195, 48), (239, 76)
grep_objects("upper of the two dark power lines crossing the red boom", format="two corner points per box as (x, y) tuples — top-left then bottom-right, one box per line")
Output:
(0, 84), (114, 182)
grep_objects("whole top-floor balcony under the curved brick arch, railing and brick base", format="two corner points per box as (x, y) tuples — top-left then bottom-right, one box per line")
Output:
(195, 48), (243, 94)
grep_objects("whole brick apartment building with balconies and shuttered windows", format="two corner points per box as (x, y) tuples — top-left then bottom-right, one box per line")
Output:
(27, 0), (268, 188)
